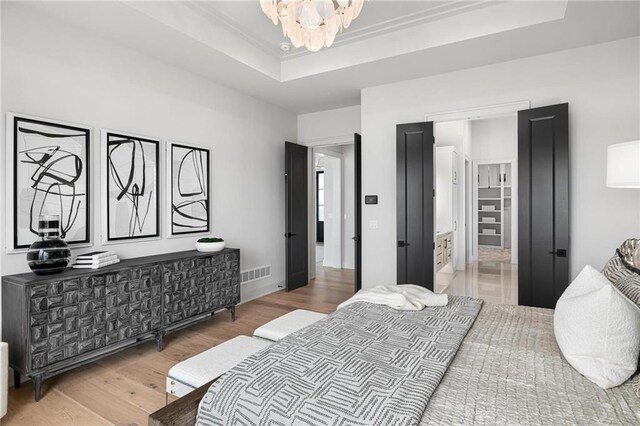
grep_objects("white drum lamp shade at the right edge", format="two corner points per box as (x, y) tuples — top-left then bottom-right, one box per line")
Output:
(607, 141), (640, 188)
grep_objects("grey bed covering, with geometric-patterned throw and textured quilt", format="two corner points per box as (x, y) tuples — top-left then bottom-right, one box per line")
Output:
(198, 297), (640, 426)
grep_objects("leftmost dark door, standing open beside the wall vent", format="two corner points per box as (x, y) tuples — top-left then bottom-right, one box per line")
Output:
(284, 142), (309, 291)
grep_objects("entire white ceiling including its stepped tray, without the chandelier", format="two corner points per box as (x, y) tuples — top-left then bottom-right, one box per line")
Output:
(20, 0), (640, 113)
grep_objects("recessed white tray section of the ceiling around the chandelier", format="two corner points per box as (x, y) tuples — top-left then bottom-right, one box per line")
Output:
(127, 0), (567, 82)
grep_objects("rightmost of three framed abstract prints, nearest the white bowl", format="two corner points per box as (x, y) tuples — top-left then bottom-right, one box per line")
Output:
(167, 142), (211, 237)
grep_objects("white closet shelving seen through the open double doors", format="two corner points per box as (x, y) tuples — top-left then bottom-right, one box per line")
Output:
(477, 162), (512, 248)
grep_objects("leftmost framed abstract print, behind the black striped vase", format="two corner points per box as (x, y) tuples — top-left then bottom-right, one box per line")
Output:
(8, 113), (92, 250)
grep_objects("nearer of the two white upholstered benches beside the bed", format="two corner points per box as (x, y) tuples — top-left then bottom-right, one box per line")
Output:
(166, 336), (273, 400)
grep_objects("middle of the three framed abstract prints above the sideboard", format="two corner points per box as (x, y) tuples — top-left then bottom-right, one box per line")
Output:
(104, 131), (160, 242)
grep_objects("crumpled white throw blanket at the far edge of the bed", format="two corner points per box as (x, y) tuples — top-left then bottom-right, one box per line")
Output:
(338, 284), (448, 311)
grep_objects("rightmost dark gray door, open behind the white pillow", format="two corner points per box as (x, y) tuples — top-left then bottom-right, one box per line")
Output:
(518, 104), (570, 308)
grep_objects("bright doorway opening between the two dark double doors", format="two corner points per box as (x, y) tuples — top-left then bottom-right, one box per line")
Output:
(434, 113), (518, 304)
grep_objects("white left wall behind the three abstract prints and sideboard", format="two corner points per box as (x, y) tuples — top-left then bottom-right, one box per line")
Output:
(0, 2), (296, 302)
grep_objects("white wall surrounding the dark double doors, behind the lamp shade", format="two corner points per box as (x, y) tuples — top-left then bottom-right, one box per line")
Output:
(362, 37), (640, 287)
